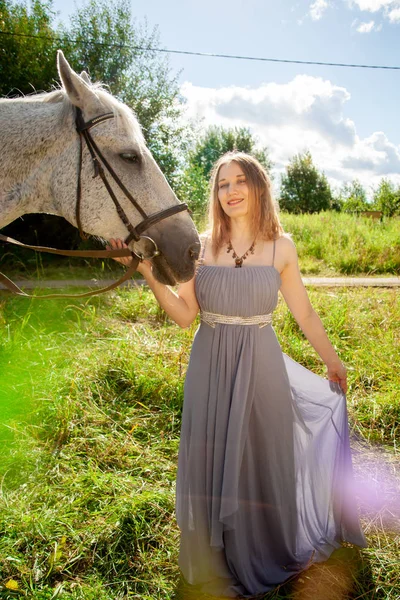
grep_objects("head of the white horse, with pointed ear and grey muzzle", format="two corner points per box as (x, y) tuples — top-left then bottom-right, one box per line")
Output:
(53, 51), (200, 285)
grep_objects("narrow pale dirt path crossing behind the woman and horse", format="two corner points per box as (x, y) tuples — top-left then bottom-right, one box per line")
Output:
(0, 277), (400, 290)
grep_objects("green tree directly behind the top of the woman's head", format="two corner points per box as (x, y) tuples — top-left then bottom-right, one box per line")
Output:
(177, 126), (272, 221)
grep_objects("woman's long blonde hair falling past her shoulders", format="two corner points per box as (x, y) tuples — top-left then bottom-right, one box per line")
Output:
(208, 151), (284, 256)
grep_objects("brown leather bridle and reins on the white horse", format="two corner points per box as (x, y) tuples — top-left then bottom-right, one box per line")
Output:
(0, 108), (190, 298)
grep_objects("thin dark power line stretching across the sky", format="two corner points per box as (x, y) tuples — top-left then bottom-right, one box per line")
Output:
(0, 31), (400, 71)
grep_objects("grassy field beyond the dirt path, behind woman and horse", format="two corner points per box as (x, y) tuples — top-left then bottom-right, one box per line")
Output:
(0, 212), (400, 280)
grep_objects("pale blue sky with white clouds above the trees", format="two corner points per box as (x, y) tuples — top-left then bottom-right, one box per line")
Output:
(54, 0), (400, 189)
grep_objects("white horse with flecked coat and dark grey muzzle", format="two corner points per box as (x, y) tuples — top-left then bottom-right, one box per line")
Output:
(0, 51), (200, 285)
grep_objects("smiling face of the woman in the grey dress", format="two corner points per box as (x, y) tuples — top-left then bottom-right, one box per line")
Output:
(217, 161), (250, 218)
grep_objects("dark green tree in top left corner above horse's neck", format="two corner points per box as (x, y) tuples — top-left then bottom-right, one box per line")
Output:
(0, 0), (60, 96)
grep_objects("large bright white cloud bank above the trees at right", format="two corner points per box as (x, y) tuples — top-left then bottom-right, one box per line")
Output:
(181, 75), (400, 195)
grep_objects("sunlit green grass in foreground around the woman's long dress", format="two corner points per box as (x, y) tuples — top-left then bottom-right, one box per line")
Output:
(0, 289), (400, 600)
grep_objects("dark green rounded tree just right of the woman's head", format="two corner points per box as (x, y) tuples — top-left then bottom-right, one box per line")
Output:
(279, 152), (332, 214)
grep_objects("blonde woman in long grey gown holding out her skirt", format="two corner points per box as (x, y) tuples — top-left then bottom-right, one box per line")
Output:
(111, 152), (365, 598)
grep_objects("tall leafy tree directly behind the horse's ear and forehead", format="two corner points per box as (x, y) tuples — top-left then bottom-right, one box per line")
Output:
(65, 0), (186, 185)
